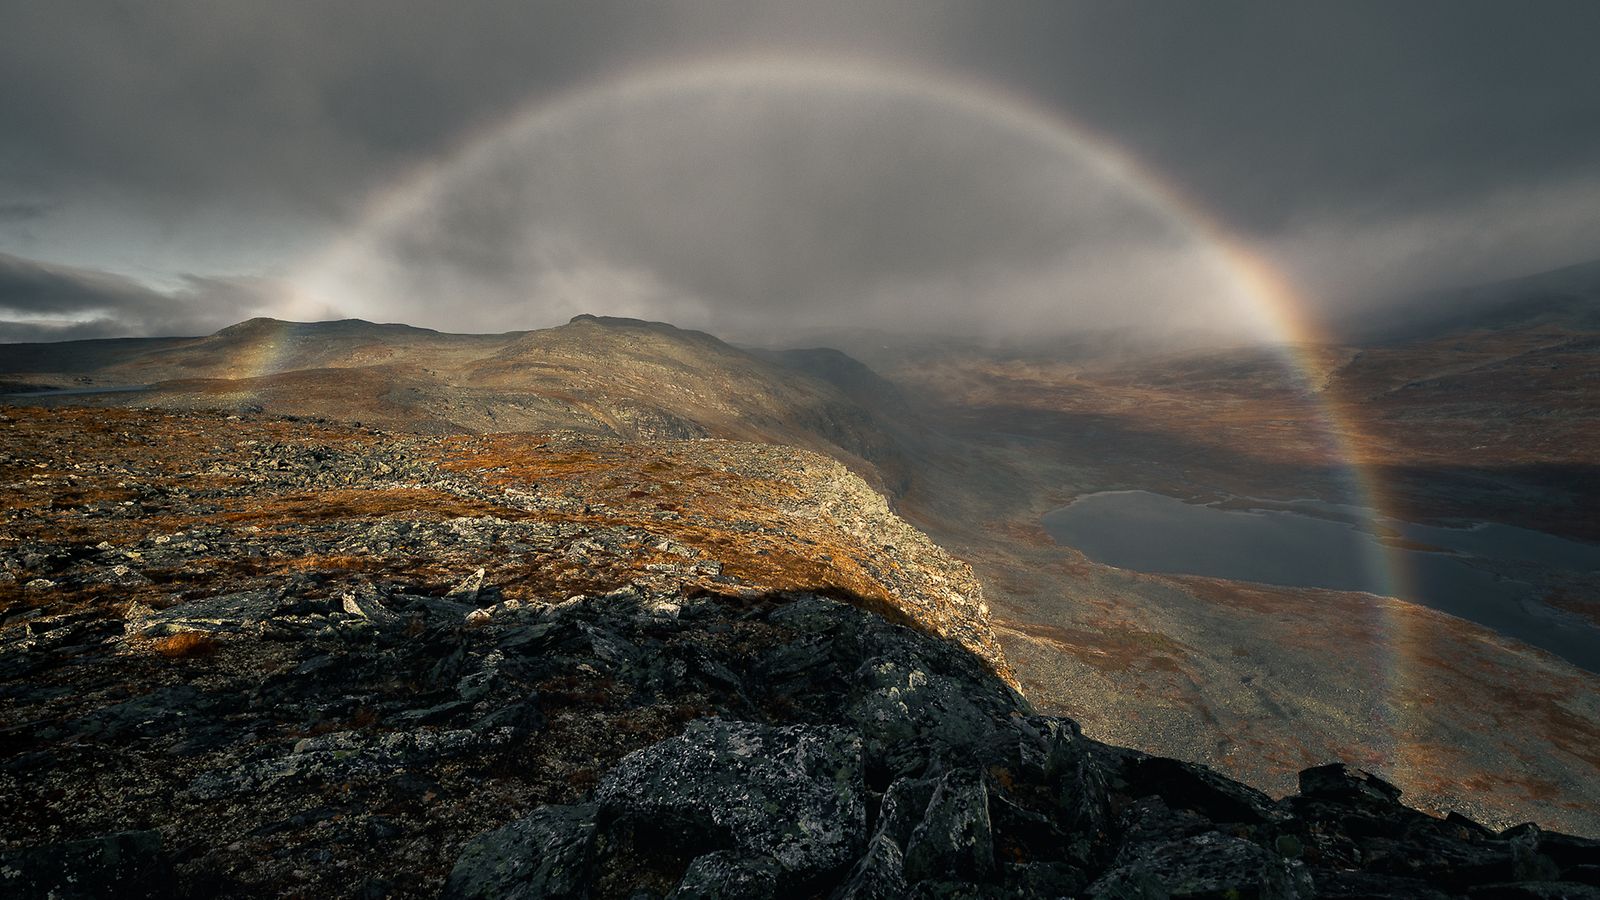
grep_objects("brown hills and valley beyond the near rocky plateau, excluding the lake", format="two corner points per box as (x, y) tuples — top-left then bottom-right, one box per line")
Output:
(9, 296), (1600, 833)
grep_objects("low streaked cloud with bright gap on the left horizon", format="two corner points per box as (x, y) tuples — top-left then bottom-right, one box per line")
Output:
(0, 253), (270, 341)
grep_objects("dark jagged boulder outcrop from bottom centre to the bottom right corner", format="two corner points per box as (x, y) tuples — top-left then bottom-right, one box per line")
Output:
(419, 596), (1600, 900)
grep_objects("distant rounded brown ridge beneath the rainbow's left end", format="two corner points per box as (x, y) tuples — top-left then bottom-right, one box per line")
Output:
(0, 315), (893, 490)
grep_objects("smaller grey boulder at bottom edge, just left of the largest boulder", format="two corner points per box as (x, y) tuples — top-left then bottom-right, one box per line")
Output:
(443, 804), (598, 900)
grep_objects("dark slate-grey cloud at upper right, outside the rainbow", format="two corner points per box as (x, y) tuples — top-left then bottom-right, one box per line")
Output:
(940, 0), (1600, 232)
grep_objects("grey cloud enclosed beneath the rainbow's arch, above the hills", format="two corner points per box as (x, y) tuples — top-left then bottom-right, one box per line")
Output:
(305, 71), (1226, 336)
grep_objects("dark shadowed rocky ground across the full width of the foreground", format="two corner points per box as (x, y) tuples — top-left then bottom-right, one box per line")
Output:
(9, 570), (1600, 898)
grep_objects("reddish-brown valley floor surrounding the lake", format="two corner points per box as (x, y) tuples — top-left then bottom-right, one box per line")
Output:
(886, 341), (1600, 833)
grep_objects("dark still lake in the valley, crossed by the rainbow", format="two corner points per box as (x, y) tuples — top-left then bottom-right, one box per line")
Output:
(1043, 490), (1600, 671)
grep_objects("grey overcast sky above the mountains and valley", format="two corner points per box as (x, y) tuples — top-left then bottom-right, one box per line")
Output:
(0, 0), (1600, 340)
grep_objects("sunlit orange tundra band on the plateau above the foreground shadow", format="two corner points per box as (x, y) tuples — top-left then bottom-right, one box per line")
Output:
(0, 408), (1000, 672)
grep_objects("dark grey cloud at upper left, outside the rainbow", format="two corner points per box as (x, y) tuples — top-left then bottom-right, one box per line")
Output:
(0, 0), (934, 216)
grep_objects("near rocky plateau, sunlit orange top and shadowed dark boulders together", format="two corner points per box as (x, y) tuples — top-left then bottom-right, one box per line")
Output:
(0, 408), (1600, 900)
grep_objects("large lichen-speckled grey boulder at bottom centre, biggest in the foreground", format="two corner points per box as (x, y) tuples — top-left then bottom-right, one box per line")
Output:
(595, 719), (867, 878)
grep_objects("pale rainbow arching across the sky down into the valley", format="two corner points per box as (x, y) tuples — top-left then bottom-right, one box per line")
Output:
(285, 54), (1406, 762)
